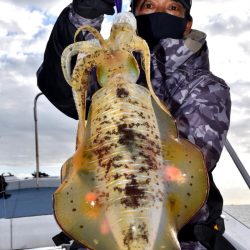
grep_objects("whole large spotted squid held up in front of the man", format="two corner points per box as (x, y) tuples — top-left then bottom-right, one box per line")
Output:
(54, 13), (208, 250)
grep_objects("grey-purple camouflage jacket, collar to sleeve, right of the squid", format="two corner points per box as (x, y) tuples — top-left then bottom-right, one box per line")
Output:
(147, 34), (231, 171)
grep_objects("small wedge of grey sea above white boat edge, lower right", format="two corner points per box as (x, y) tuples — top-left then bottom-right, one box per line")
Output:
(224, 205), (250, 228)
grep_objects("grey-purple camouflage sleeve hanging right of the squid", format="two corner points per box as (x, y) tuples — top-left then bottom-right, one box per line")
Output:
(175, 73), (231, 171)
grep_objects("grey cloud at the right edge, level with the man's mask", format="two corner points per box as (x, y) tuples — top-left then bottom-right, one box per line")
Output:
(204, 14), (250, 36)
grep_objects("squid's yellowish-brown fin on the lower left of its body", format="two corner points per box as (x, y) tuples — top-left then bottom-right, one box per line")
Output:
(54, 165), (118, 250)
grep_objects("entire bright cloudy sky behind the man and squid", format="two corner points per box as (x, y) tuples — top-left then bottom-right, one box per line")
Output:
(0, 0), (250, 204)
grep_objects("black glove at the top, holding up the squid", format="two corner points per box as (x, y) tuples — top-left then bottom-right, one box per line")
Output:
(73, 0), (115, 19)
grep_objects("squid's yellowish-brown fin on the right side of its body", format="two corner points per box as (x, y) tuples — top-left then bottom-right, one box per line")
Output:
(152, 99), (209, 230)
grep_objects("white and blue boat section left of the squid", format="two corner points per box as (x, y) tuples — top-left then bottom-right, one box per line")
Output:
(0, 176), (61, 250)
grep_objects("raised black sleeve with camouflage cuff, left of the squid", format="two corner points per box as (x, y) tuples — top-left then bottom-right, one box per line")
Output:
(37, 5), (103, 119)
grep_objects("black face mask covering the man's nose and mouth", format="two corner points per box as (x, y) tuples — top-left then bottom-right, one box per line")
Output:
(135, 12), (188, 49)
